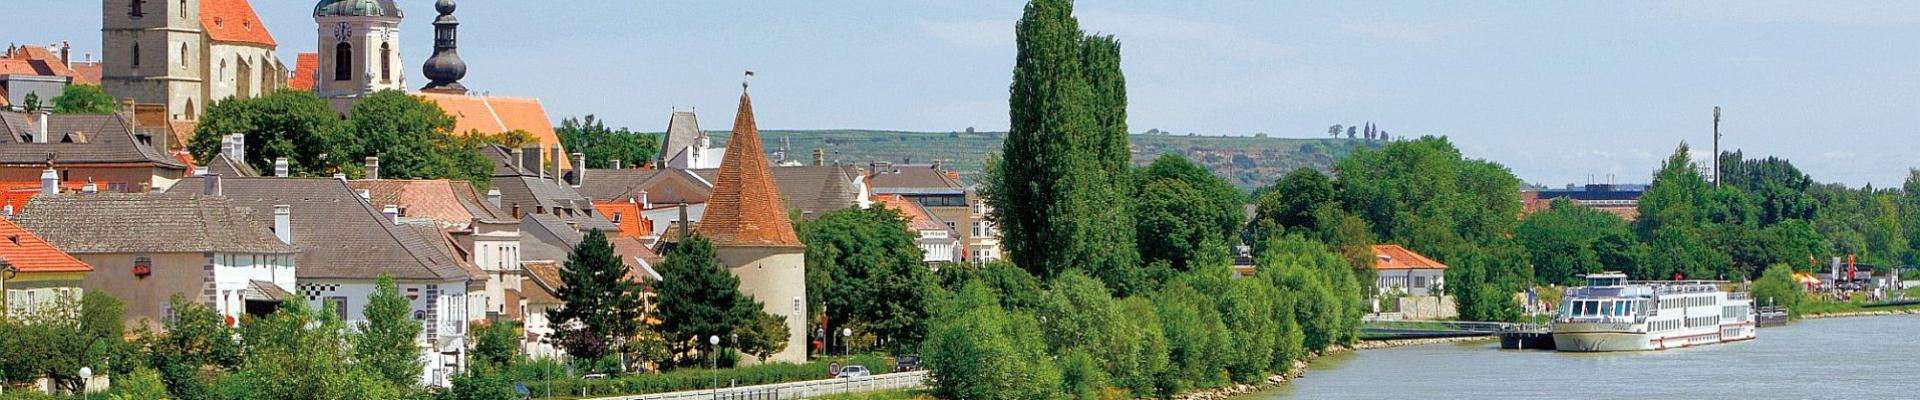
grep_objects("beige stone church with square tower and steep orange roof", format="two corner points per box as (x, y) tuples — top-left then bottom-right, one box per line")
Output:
(100, 0), (288, 121)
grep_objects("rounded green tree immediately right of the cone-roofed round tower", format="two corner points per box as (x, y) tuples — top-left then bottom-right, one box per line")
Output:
(799, 208), (933, 350)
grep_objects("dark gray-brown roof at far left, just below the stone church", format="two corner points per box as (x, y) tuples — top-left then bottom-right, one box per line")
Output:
(0, 112), (186, 169)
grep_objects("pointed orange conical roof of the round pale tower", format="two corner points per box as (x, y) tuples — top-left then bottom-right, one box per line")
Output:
(699, 92), (804, 248)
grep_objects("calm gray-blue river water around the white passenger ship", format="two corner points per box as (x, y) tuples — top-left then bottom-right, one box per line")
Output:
(1244, 315), (1920, 400)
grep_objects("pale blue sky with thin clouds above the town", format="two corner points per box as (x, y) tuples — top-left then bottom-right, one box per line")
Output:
(15, 0), (1920, 187)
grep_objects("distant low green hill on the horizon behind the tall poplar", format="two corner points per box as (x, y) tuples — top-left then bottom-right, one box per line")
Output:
(691, 129), (1379, 190)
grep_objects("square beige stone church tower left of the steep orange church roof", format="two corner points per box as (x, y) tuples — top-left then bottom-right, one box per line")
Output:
(100, 0), (207, 119)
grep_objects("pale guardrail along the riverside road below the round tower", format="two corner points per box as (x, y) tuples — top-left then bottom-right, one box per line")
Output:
(593, 371), (927, 400)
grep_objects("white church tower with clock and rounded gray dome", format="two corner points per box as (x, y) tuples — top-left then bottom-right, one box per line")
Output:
(313, 0), (407, 112)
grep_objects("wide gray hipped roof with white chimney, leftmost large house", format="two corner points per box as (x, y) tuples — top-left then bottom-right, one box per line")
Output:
(13, 193), (294, 254)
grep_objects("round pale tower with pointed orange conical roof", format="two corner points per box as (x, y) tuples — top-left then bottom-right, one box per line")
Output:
(699, 73), (806, 363)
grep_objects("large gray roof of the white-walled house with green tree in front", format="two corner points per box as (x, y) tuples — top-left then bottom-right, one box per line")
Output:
(167, 177), (472, 281)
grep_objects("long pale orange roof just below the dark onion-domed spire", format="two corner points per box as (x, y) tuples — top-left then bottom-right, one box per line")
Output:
(413, 92), (572, 169)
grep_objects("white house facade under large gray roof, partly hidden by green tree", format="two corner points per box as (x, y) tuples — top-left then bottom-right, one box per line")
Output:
(300, 279), (480, 387)
